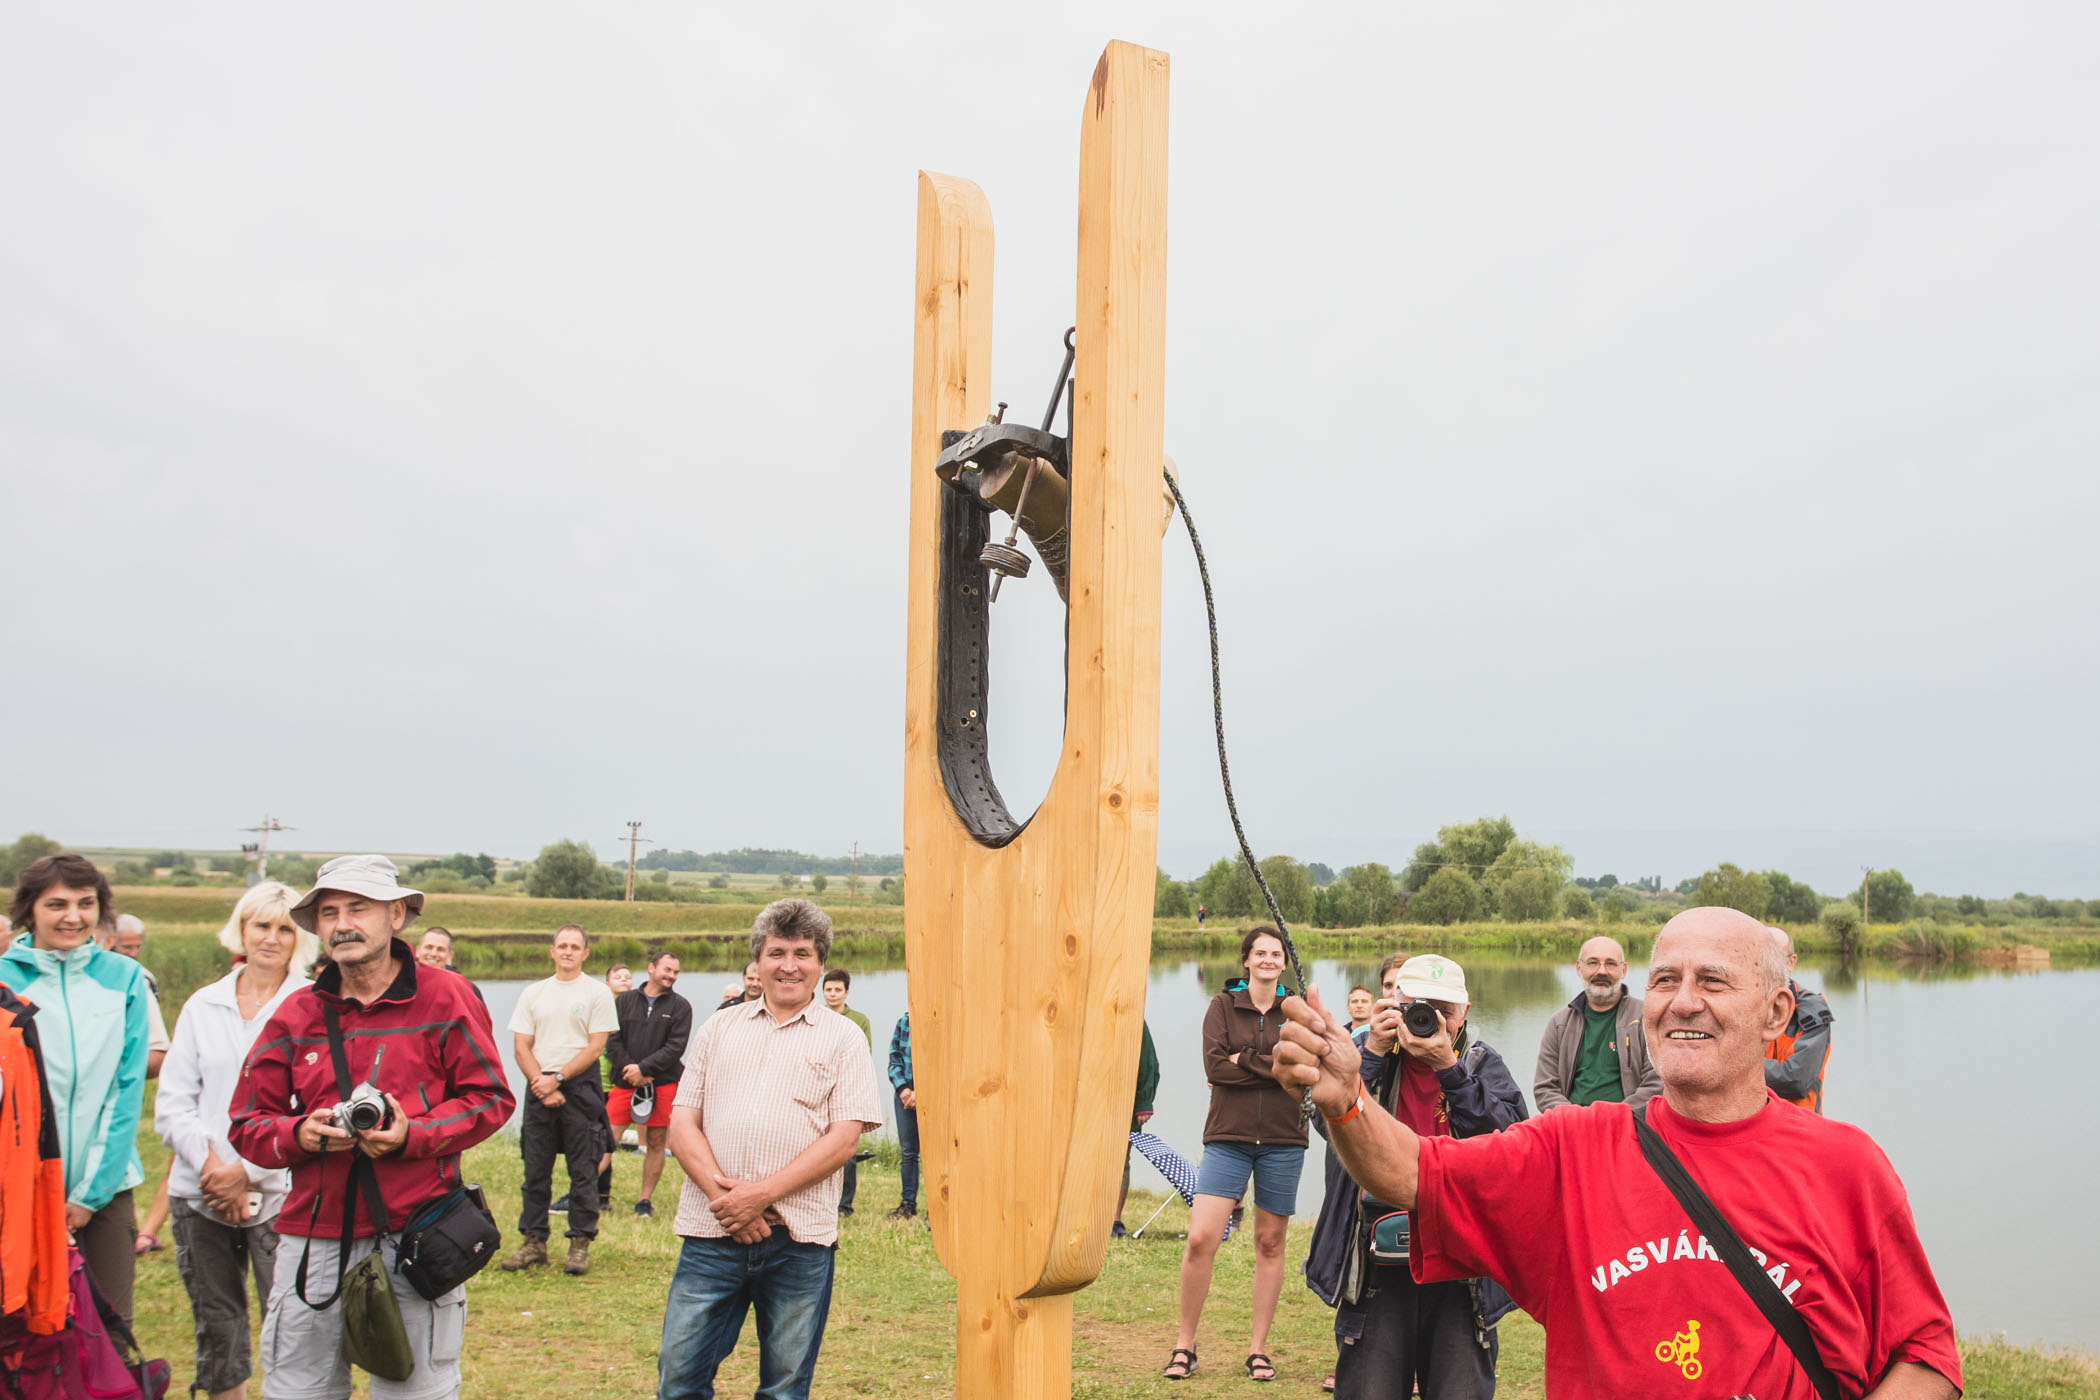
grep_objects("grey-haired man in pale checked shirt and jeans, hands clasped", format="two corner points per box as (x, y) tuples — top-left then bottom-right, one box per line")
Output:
(657, 898), (882, 1400)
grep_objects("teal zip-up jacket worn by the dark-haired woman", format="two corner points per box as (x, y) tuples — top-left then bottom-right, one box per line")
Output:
(0, 934), (151, 1211)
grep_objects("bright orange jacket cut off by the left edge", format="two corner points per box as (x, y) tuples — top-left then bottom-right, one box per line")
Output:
(0, 984), (71, 1335)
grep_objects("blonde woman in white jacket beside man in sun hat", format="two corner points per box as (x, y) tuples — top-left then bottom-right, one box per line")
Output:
(153, 879), (319, 1400)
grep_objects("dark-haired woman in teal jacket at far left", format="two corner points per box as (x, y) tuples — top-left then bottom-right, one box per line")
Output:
(0, 854), (149, 1322)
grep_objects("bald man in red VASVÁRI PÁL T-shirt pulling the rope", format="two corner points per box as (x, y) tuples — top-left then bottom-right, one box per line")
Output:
(1277, 909), (1961, 1400)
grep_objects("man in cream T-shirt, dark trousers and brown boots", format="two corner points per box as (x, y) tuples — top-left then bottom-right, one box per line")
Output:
(504, 924), (620, 1274)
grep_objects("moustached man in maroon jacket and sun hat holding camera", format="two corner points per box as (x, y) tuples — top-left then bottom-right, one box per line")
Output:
(229, 856), (517, 1400)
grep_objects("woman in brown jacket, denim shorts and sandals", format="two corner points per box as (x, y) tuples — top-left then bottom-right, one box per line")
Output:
(1161, 924), (1306, 1381)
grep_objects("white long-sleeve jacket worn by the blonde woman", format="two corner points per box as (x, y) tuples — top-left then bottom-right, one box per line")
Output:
(153, 968), (311, 1224)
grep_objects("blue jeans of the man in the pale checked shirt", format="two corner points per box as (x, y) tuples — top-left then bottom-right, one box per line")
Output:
(657, 1226), (836, 1400)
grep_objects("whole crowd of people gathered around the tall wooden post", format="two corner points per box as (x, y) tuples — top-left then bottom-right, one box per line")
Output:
(0, 854), (1931, 1400)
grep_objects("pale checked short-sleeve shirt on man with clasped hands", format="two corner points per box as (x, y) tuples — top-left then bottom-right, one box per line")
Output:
(674, 997), (882, 1245)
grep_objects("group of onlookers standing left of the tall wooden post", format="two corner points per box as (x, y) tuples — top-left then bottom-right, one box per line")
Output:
(0, 854), (918, 1398)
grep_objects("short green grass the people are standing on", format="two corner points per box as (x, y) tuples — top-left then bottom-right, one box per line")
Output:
(122, 1102), (2100, 1400)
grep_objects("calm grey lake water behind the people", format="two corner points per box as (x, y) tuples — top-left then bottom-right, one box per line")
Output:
(468, 953), (2100, 1348)
